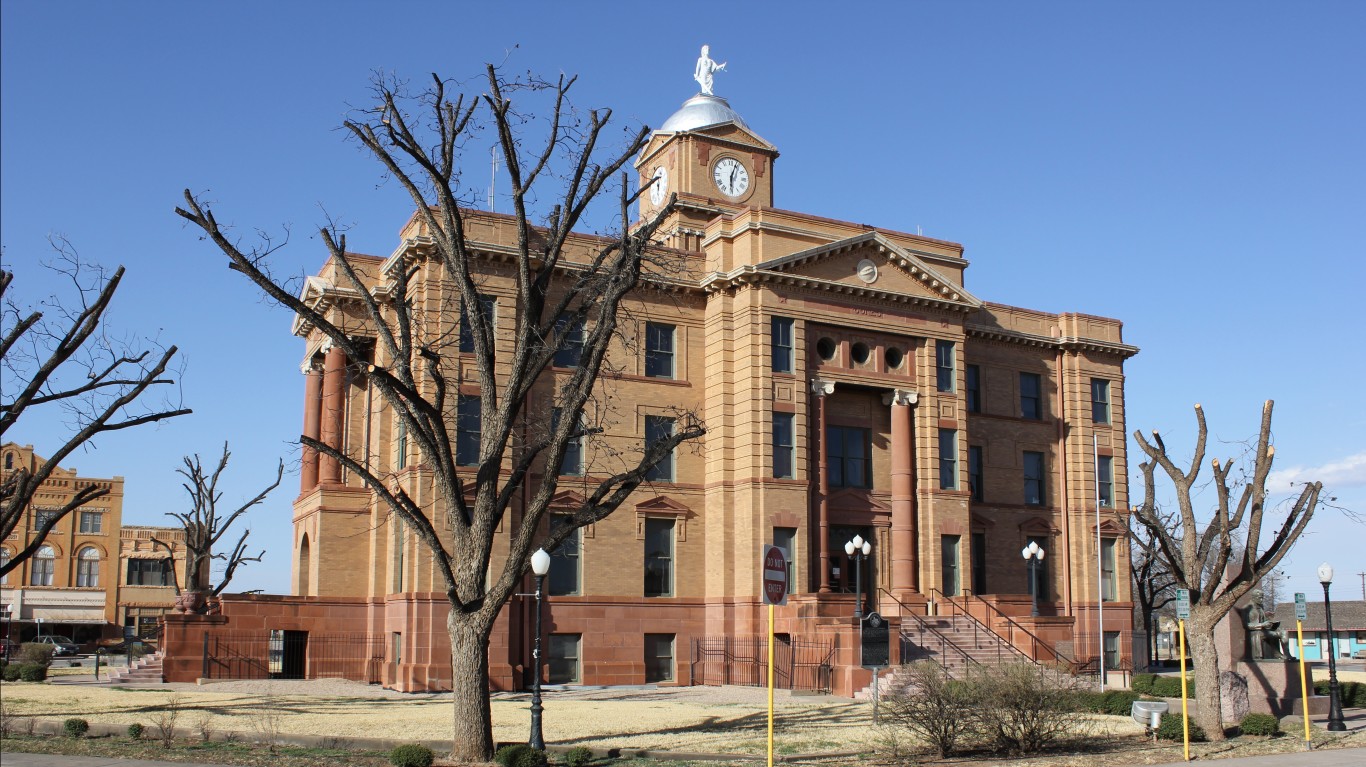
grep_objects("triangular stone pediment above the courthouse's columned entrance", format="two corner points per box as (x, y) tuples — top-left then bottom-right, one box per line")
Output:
(757, 231), (982, 309)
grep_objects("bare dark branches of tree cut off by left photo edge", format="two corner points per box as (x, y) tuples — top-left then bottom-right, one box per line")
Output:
(0, 244), (190, 576)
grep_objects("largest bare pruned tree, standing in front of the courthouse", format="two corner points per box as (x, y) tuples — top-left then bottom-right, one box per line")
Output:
(176, 66), (705, 762)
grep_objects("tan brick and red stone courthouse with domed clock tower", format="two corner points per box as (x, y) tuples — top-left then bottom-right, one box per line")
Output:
(168, 82), (1137, 693)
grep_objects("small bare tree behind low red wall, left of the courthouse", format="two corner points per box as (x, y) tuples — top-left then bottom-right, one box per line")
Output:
(152, 443), (284, 611)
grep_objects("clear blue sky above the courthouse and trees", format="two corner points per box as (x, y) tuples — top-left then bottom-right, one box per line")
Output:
(0, 0), (1366, 596)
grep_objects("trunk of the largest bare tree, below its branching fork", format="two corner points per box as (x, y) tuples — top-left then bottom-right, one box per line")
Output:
(445, 610), (493, 762)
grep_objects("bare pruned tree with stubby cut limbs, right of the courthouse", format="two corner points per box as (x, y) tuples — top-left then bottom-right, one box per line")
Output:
(1134, 399), (1322, 740)
